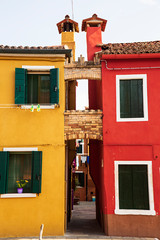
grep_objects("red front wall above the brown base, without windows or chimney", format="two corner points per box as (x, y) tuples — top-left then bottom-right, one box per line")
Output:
(102, 57), (160, 215)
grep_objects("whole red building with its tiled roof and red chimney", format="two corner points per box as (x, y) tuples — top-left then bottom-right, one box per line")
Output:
(82, 15), (160, 237)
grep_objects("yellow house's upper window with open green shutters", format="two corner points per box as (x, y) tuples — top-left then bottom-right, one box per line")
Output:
(15, 68), (59, 105)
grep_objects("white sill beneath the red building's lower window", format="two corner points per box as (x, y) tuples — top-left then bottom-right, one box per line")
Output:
(115, 209), (156, 215)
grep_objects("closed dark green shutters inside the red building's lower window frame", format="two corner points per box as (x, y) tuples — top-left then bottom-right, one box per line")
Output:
(119, 165), (149, 210)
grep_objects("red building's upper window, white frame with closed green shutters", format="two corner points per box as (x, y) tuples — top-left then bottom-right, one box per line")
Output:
(116, 74), (148, 121)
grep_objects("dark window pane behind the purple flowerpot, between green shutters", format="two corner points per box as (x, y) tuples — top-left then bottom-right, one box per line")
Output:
(7, 153), (32, 193)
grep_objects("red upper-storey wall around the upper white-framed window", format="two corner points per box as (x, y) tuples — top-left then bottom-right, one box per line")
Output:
(102, 59), (160, 145)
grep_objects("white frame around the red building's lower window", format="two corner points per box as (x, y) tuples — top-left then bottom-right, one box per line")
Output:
(114, 161), (156, 215)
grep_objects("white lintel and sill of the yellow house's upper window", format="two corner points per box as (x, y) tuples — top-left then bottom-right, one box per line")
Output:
(21, 65), (57, 109)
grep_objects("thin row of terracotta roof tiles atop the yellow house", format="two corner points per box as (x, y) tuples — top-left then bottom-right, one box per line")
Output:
(0, 45), (65, 50)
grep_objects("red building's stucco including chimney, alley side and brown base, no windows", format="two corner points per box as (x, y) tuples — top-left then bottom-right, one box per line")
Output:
(87, 19), (160, 237)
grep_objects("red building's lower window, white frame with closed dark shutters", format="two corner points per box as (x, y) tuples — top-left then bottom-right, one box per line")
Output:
(115, 161), (154, 215)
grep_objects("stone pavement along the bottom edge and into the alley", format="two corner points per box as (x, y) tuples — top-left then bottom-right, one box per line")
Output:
(0, 202), (157, 240)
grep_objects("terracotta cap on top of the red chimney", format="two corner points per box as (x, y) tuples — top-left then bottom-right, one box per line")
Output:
(82, 14), (107, 32)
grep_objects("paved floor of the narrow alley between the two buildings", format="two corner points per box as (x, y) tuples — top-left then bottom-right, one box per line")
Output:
(66, 202), (106, 238)
